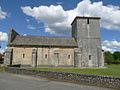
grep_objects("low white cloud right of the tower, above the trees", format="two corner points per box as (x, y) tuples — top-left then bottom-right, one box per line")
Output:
(102, 40), (120, 52)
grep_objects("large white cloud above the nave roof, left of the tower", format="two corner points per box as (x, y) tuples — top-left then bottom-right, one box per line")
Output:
(21, 5), (70, 34)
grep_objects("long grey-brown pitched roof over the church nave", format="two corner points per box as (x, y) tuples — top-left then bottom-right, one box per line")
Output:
(9, 35), (77, 47)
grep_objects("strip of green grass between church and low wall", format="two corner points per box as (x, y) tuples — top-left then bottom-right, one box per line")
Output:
(32, 64), (120, 77)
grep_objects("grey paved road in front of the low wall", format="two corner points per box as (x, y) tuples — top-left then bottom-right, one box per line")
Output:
(0, 72), (112, 90)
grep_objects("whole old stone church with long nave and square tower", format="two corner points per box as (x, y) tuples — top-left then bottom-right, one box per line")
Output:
(4, 16), (104, 67)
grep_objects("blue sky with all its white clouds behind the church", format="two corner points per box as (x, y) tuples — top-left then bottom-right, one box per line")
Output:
(0, 0), (120, 52)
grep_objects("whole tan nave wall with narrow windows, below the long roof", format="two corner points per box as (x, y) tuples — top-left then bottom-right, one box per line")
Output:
(10, 47), (74, 67)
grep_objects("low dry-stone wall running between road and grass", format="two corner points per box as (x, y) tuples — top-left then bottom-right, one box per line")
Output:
(5, 67), (120, 90)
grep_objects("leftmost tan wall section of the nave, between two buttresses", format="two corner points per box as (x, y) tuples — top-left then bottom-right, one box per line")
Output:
(11, 47), (34, 65)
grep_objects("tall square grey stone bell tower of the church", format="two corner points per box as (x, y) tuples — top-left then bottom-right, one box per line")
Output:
(71, 17), (104, 67)
